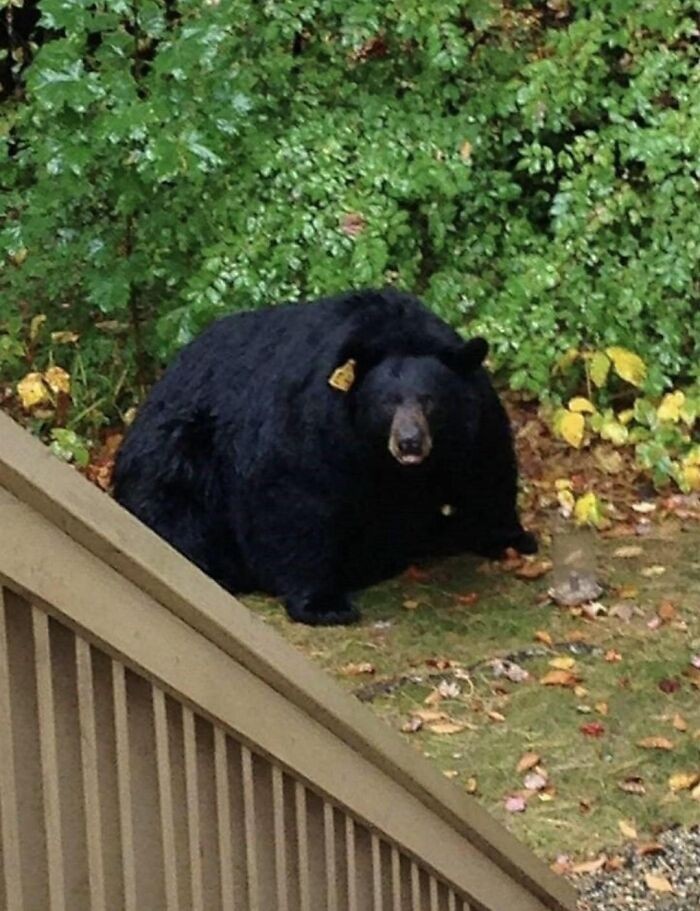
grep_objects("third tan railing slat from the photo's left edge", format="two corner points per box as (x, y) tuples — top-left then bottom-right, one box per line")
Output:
(75, 636), (106, 911)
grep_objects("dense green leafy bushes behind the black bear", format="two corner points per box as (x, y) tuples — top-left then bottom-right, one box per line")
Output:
(0, 0), (700, 434)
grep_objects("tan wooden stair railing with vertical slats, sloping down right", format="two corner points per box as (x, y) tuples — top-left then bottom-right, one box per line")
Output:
(0, 415), (574, 911)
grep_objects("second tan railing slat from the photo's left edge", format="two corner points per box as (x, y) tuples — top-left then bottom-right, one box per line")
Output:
(32, 607), (66, 911)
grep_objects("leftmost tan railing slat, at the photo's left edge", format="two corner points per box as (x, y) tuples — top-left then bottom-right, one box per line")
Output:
(0, 586), (22, 911)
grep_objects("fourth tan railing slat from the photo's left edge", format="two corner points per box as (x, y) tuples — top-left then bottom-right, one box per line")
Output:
(112, 661), (137, 911)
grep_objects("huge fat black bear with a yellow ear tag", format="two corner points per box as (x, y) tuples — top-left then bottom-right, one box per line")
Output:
(114, 290), (537, 624)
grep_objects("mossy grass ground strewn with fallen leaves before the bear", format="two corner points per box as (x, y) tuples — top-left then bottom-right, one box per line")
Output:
(246, 525), (700, 860)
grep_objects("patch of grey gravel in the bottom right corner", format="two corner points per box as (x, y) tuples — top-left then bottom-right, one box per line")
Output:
(573, 828), (700, 911)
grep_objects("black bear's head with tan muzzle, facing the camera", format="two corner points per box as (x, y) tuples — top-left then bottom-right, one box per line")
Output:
(351, 338), (488, 467)
